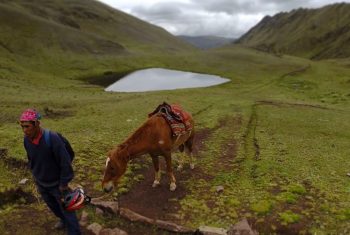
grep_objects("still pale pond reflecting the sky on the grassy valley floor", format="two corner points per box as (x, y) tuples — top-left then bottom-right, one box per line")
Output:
(105, 68), (230, 92)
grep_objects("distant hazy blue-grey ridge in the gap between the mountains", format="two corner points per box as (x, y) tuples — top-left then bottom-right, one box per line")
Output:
(178, 35), (235, 49)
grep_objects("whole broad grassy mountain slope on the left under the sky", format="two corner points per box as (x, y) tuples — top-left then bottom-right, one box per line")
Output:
(0, 0), (194, 54)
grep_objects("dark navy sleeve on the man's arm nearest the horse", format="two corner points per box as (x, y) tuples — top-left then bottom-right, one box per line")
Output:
(50, 132), (74, 186)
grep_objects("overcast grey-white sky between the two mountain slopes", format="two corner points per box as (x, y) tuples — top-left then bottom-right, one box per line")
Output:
(99, 0), (350, 38)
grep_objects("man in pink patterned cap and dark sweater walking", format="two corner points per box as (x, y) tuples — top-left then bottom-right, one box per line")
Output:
(20, 109), (81, 235)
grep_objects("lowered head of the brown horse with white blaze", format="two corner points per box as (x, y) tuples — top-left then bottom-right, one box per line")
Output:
(102, 148), (127, 193)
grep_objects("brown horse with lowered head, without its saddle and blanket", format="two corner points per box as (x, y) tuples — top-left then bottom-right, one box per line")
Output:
(102, 114), (194, 192)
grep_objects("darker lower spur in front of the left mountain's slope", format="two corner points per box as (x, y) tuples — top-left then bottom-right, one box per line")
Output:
(0, 4), (125, 55)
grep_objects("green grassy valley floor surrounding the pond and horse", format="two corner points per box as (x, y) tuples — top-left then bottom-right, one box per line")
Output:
(0, 41), (350, 233)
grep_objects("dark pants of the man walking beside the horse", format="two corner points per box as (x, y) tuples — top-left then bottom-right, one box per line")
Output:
(37, 184), (81, 235)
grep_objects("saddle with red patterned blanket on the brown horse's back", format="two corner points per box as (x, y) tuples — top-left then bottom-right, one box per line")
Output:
(148, 102), (192, 136)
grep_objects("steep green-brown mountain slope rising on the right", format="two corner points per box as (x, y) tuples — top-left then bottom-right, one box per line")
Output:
(237, 3), (350, 59)
